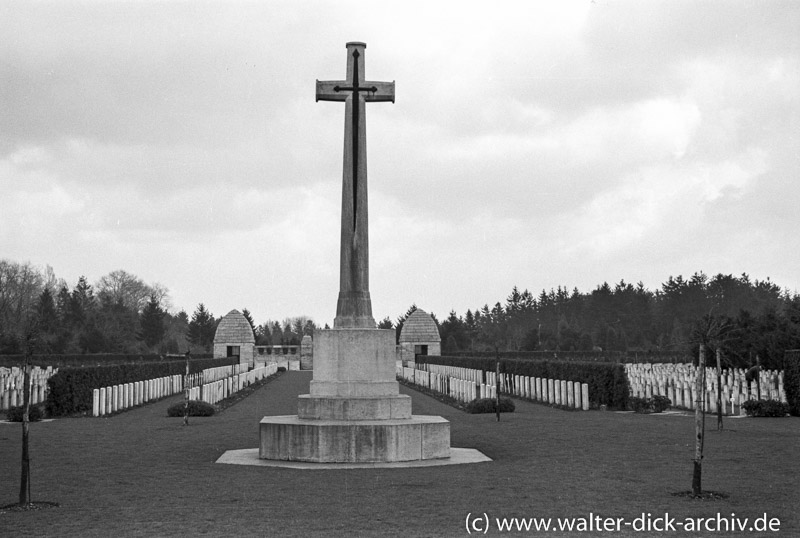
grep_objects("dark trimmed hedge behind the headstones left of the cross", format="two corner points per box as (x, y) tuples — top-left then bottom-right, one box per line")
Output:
(45, 357), (239, 417)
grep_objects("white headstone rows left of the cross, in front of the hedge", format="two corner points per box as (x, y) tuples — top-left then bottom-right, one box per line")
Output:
(92, 363), (278, 417)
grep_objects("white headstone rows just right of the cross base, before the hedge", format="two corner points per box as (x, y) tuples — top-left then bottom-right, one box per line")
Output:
(397, 364), (589, 411)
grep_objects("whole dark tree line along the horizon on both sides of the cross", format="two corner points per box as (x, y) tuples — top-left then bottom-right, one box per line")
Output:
(0, 260), (800, 368)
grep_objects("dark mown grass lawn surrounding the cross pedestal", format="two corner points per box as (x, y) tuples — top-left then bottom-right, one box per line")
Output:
(0, 372), (800, 537)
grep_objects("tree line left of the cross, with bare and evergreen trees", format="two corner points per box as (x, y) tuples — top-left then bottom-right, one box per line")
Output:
(0, 260), (315, 354)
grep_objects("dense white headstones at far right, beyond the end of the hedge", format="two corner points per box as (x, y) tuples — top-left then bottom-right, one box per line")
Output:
(625, 363), (786, 415)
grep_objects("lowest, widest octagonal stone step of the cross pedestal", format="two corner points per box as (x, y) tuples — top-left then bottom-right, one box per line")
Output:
(258, 415), (450, 463)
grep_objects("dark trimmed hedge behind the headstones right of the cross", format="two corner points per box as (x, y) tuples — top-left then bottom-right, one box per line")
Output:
(417, 355), (630, 409)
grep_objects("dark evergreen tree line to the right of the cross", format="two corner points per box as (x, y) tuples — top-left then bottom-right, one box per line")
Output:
(410, 272), (800, 368)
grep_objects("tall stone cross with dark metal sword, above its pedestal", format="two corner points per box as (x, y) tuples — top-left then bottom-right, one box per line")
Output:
(317, 42), (394, 329)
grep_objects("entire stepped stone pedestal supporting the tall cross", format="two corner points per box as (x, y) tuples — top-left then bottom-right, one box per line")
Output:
(258, 325), (450, 463)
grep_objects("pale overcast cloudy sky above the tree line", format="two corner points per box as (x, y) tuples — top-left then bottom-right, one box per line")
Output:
(0, 0), (800, 325)
